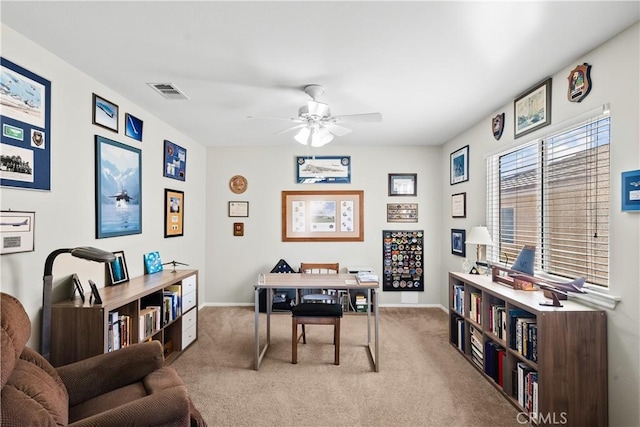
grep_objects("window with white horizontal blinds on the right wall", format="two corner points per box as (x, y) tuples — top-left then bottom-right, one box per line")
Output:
(487, 115), (610, 287)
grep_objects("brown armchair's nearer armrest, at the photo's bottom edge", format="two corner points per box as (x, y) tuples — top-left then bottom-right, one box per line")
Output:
(69, 386), (190, 427)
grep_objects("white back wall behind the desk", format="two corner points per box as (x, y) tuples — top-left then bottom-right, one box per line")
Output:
(205, 145), (441, 305)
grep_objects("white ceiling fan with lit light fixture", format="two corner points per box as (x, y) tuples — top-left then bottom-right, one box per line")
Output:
(251, 84), (382, 147)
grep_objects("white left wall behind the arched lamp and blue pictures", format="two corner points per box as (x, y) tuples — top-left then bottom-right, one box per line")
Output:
(0, 24), (206, 349)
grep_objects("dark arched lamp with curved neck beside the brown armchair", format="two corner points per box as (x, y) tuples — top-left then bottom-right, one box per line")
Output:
(40, 246), (116, 360)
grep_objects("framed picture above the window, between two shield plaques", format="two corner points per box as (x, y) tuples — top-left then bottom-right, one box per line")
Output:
(513, 78), (551, 138)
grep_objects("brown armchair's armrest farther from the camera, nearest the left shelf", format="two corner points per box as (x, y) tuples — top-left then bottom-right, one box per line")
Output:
(56, 341), (164, 406)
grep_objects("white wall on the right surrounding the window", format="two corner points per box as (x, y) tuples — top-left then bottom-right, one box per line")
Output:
(440, 24), (640, 426)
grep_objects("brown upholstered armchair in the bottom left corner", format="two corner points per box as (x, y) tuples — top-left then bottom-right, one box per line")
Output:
(0, 293), (206, 426)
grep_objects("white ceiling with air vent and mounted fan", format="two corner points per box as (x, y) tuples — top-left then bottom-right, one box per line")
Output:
(1, 0), (640, 146)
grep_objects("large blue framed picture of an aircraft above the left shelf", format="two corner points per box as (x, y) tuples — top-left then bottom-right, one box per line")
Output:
(95, 135), (142, 239)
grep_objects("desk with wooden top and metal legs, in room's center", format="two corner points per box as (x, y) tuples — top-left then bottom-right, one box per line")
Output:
(254, 273), (380, 372)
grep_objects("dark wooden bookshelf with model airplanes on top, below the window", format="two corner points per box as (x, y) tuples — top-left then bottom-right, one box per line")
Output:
(449, 273), (608, 426)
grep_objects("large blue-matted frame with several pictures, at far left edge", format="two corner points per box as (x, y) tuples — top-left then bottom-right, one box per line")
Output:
(0, 58), (51, 190)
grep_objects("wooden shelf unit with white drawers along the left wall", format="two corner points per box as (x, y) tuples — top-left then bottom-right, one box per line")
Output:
(50, 270), (198, 366)
